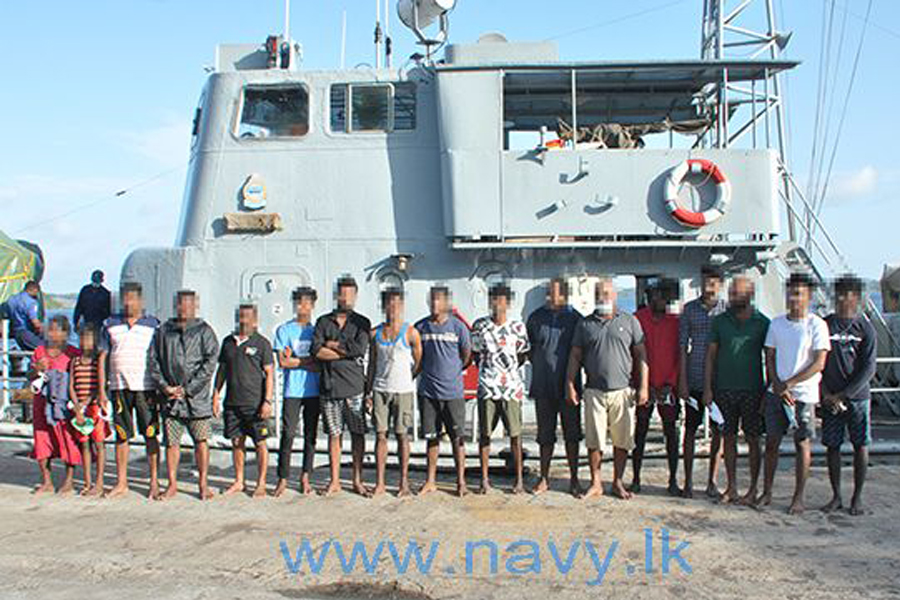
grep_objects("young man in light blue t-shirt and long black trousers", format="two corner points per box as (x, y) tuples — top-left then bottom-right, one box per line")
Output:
(275, 287), (319, 497)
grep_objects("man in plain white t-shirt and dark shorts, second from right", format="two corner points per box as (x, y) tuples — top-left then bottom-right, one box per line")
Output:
(758, 273), (831, 514)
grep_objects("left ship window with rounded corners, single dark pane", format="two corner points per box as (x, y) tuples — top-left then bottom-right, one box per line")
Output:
(237, 85), (309, 139)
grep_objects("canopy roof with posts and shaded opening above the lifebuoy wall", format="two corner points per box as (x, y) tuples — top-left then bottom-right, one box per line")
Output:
(437, 60), (799, 149)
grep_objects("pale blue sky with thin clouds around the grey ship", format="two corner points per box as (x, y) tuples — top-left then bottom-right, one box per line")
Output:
(0, 0), (900, 292)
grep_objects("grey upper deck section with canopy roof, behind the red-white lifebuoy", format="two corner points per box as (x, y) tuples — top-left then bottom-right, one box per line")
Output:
(436, 38), (797, 262)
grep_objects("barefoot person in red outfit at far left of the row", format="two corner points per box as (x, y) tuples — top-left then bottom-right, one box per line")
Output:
(31, 316), (81, 495)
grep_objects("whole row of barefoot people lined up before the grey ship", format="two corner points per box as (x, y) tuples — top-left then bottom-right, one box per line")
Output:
(26, 268), (874, 512)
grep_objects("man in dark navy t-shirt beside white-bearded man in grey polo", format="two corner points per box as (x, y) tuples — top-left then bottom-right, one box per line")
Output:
(526, 278), (582, 498)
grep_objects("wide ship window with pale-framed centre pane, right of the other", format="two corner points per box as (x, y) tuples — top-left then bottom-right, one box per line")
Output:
(331, 82), (416, 133)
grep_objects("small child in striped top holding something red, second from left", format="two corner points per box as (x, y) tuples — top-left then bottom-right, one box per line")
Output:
(69, 323), (110, 496)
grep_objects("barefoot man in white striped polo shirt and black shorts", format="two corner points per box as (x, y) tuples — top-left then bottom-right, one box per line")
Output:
(100, 282), (159, 500)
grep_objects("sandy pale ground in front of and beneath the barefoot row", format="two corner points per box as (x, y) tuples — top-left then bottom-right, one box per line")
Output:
(0, 444), (900, 600)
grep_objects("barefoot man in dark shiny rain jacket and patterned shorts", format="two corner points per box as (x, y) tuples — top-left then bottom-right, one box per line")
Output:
(150, 290), (219, 500)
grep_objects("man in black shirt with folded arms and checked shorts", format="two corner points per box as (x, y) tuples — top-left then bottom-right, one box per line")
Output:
(312, 276), (372, 497)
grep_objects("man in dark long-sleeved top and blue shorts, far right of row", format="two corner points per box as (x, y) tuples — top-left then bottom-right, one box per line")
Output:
(822, 275), (877, 515)
